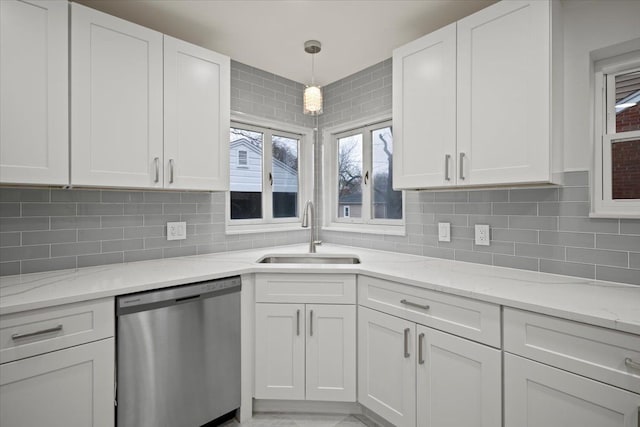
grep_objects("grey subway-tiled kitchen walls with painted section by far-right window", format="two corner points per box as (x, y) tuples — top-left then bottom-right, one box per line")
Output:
(0, 0), (640, 285)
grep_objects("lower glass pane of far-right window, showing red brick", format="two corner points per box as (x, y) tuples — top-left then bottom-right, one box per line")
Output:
(611, 139), (640, 200)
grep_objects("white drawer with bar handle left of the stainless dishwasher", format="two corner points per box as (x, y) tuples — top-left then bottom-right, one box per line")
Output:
(0, 298), (114, 363)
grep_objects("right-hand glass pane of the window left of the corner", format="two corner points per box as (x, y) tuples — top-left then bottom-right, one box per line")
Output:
(271, 135), (298, 218)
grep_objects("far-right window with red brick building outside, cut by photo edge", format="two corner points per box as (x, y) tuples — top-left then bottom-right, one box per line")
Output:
(592, 55), (640, 217)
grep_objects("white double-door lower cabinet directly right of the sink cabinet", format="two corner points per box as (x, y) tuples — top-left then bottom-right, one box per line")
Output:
(358, 307), (502, 427)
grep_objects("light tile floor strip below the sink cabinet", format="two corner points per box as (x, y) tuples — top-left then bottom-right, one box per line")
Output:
(221, 412), (376, 427)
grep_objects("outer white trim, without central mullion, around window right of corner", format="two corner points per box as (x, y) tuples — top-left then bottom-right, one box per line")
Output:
(321, 114), (407, 236)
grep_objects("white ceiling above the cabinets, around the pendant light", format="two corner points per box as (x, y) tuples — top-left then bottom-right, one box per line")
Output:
(76, 0), (495, 85)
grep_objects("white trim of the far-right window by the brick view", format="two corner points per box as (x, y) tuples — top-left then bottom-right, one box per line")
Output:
(589, 52), (640, 218)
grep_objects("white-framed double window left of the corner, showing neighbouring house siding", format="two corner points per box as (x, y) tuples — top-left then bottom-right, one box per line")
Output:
(227, 118), (311, 233)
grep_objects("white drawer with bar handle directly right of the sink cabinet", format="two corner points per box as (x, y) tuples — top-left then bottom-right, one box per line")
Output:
(358, 276), (500, 348)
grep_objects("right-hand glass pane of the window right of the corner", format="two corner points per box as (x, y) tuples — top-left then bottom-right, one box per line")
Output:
(371, 127), (402, 219)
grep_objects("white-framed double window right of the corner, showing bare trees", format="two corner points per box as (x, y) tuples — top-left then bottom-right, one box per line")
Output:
(324, 121), (404, 234)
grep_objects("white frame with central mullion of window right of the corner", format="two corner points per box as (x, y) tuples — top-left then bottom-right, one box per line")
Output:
(321, 115), (406, 236)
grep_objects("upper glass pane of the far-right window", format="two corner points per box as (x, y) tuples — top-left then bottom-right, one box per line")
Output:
(615, 71), (640, 133)
